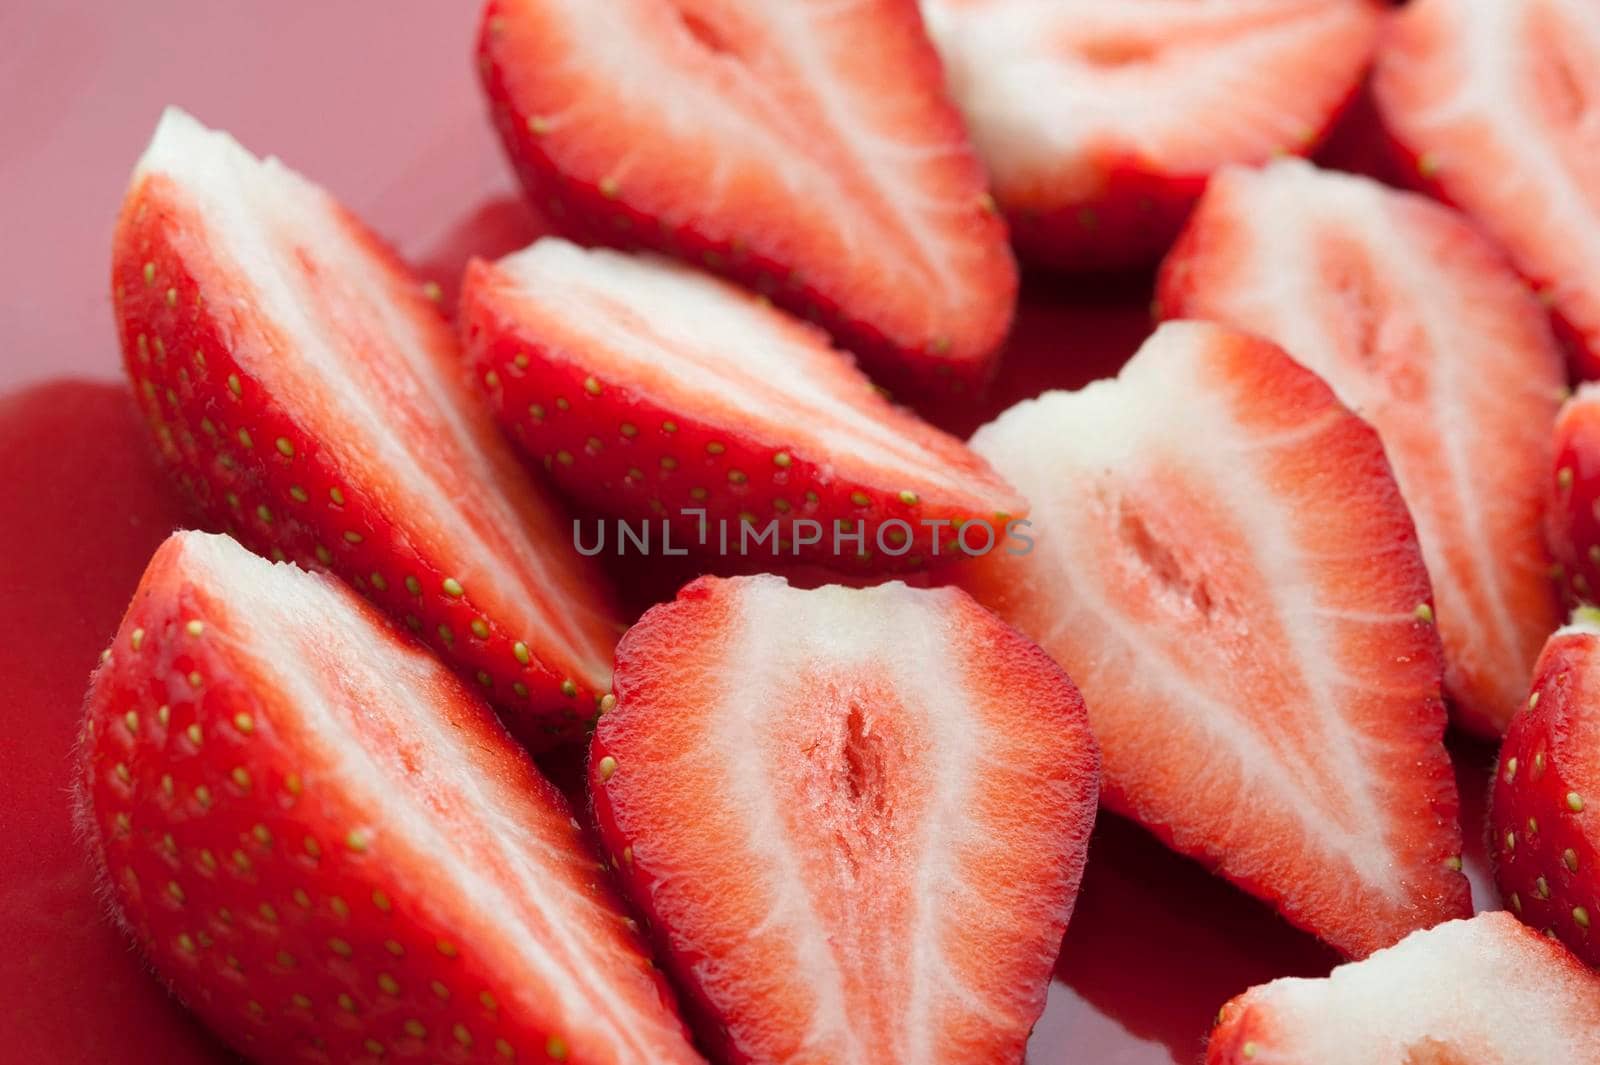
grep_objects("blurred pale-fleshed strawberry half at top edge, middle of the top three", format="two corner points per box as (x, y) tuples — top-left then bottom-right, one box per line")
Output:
(922, 0), (1381, 269)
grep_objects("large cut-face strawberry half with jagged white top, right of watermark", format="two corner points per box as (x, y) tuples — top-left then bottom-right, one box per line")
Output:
(963, 316), (1470, 955)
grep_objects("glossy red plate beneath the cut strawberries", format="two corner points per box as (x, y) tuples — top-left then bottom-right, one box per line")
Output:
(0, 0), (1493, 1065)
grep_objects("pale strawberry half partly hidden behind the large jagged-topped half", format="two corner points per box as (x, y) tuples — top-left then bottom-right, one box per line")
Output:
(1157, 160), (1565, 736)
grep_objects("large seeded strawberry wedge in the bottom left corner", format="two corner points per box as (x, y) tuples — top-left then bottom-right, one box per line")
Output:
(82, 533), (699, 1065)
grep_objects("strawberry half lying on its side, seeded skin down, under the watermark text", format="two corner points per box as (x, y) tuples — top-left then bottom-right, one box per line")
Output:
(461, 238), (1026, 569)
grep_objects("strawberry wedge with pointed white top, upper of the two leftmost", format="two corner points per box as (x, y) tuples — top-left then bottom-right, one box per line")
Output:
(114, 110), (619, 744)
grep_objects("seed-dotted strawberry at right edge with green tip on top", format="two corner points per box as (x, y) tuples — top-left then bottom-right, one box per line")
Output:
(1490, 608), (1600, 967)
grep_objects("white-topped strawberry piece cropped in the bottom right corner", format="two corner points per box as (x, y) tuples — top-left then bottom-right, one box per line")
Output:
(1205, 911), (1600, 1065)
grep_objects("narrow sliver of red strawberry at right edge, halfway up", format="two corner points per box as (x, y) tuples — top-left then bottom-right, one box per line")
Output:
(1544, 384), (1600, 603)
